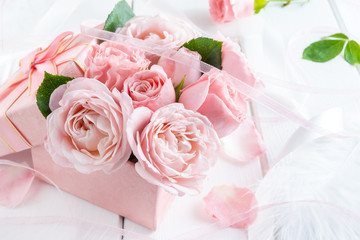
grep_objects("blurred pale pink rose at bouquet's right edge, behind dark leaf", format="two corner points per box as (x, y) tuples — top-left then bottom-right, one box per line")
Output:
(216, 33), (261, 91)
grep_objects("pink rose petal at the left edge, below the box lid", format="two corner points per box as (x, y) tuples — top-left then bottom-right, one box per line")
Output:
(0, 163), (34, 208)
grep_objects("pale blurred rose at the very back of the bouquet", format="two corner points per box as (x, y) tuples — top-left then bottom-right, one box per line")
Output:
(117, 15), (199, 49)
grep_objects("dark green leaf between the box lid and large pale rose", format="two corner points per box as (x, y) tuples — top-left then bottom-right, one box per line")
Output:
(36, 72), (74, 118)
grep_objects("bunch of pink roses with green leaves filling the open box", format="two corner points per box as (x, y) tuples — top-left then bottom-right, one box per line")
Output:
(37, 1), (264, 195)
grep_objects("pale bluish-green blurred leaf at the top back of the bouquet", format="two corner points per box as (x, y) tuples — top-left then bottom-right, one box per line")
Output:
(104, 0), (135, 32)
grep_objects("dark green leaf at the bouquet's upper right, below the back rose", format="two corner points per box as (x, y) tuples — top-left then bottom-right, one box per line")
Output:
(183, 37), (223, 69)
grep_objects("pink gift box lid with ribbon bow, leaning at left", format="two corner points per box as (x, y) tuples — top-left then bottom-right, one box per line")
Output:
(0, 32), (91, 156)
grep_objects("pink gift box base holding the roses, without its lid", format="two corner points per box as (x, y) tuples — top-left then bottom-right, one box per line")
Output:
(31, 145), (175, 230)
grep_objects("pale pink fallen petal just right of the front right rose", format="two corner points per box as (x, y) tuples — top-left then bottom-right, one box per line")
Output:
(221, 119), (265, 162)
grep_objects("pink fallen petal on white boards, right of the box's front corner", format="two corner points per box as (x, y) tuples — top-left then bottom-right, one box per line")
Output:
(203, 185), (257, 228)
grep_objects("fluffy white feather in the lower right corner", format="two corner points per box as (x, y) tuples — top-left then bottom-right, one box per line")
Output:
(249, 137), (360, 240)
